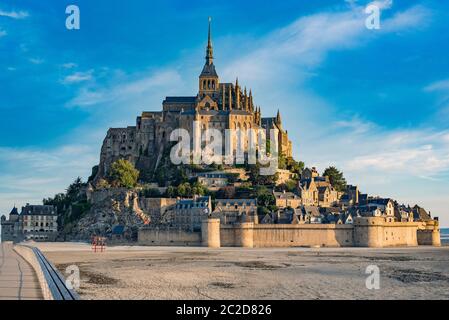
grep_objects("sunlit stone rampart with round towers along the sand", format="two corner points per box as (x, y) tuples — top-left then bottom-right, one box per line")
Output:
(139, 217), (439, 248)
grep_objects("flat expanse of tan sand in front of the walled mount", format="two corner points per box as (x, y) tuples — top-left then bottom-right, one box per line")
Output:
(29, 243), (449, 300)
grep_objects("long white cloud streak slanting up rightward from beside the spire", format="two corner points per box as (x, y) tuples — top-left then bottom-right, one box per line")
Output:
(223, 1), (430, 91)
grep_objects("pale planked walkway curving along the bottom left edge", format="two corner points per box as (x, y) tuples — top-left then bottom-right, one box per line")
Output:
(0, 243), (43, 300)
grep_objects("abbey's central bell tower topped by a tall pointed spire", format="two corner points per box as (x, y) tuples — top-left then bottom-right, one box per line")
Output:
(199, 17), (219, 98)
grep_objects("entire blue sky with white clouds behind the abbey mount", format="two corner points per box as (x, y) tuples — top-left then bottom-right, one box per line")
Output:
(0, 0), (449, 226)
